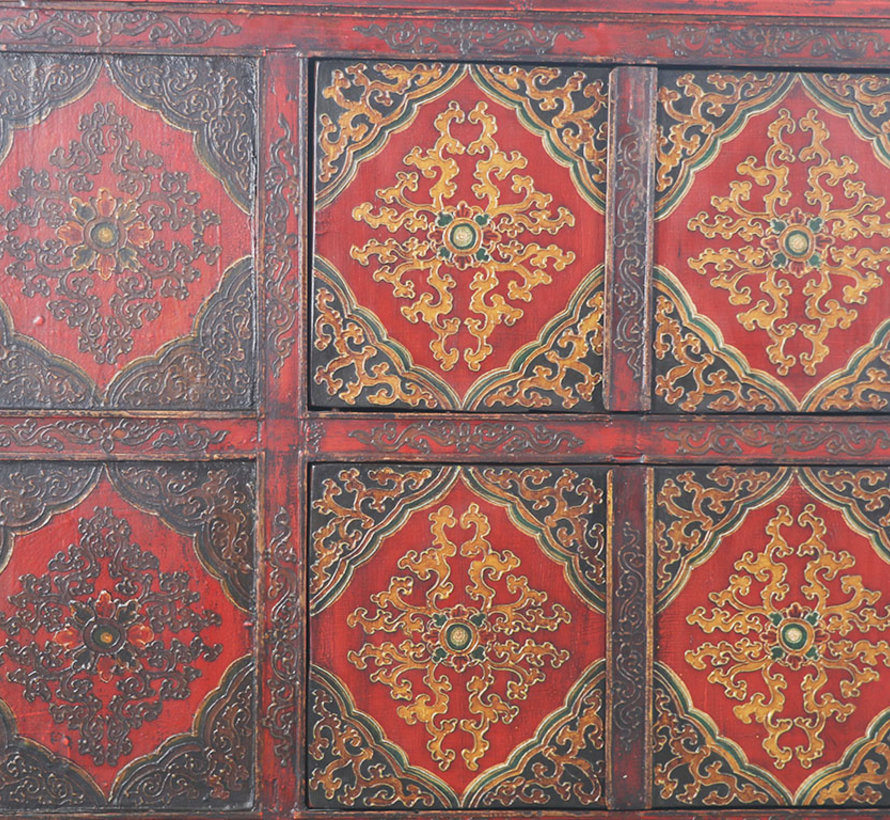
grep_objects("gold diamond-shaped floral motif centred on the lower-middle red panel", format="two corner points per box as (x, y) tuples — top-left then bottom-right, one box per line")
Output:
(347, 504), (571, 770)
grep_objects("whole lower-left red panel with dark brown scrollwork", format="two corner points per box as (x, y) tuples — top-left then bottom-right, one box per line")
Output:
(0, 462), (257, 814)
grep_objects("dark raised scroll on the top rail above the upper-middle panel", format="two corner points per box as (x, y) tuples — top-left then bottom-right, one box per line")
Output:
(355, 18), (584, 57)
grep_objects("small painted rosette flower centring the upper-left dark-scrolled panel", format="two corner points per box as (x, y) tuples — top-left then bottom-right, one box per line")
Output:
(56, 188), (154, 280)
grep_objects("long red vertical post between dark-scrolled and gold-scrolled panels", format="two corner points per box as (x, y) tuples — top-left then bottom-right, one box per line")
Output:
(256, 51), (308, 817)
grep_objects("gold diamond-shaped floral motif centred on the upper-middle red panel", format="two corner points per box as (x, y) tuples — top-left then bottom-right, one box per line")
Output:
(351, 101), (575, 371)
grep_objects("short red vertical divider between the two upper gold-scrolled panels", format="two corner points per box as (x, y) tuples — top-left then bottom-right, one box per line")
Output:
(604, 66), (657, 412)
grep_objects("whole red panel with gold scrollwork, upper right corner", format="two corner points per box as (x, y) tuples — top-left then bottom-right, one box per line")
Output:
(654, 70), (890, 412)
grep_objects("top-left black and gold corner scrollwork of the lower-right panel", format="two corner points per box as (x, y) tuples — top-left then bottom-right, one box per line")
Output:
(655, 466), (790, 609)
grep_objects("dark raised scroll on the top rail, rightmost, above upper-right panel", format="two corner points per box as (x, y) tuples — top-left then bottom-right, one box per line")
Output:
(647, 22), (890, 61)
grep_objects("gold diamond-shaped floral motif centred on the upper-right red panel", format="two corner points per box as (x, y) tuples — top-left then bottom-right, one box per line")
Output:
(689, 108), (890, 376)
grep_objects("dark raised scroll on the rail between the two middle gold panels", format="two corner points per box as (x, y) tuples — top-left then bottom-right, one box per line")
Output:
(349, 419), (584, 455)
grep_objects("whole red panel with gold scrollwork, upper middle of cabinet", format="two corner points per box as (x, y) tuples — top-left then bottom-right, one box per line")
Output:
(310, 62), (608, 412)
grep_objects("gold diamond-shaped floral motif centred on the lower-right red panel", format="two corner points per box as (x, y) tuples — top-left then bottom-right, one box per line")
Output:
(686, 504), (890, 769)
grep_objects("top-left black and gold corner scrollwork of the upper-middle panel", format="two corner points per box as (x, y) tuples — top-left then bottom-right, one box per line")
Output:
(315, 62), (465, 208)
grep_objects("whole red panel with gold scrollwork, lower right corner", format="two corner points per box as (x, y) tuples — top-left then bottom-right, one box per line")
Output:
(653, 467), (890, 808)
